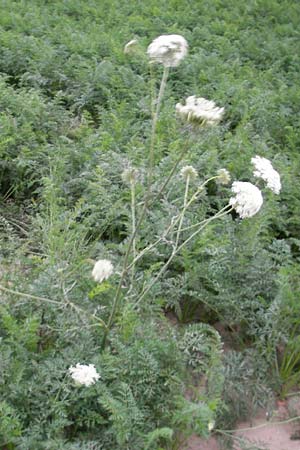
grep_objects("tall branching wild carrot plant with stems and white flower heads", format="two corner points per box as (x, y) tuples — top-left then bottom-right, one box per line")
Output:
(102, 35), (280, 349)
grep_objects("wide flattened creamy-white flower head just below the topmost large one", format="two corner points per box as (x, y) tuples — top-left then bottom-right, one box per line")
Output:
(176, 95), (224, 126)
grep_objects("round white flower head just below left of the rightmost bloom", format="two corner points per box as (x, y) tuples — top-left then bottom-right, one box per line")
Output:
(229, 181), (263, 219)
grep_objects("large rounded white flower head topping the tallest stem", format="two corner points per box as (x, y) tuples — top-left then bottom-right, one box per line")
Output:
(147, 34), (188, 67)
